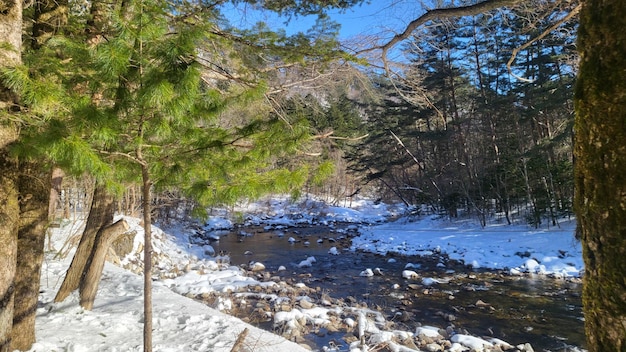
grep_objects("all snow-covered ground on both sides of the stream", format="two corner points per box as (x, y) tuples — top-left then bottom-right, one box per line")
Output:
(23, 199), (583, 352)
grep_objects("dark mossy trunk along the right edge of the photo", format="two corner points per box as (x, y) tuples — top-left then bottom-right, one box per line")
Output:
(574, 0), (626, 352)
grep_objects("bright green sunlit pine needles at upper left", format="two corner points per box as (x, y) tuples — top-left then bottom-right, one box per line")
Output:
(7, 0), (356, 209)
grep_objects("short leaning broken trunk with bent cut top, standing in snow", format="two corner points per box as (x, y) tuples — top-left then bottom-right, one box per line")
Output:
(80, 219), (130, 310)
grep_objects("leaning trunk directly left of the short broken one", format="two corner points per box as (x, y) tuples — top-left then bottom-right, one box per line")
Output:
(54, 185), (115, 302)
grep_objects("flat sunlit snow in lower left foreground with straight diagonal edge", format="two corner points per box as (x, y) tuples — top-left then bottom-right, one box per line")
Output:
(30, 260), (306, 352)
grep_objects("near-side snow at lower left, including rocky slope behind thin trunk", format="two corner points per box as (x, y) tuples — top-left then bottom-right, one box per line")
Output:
(30, 218), (306, 352)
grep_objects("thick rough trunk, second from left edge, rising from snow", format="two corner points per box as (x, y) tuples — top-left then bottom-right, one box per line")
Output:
(11, 162), (50, 351)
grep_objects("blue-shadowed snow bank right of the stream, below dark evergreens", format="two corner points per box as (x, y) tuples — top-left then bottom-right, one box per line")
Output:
(352, 216), (583, 278)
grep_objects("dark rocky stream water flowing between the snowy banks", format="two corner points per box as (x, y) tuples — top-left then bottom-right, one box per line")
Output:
(212, 227), (585, 351)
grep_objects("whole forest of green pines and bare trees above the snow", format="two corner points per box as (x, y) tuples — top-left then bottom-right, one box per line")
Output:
(0, 0), (625, 351)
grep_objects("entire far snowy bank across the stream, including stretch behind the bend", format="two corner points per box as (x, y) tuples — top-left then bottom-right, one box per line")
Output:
(236, 198), (583, 278)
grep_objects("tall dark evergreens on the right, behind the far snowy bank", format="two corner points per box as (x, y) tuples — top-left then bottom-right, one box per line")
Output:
(353, 10), (576, 225)
